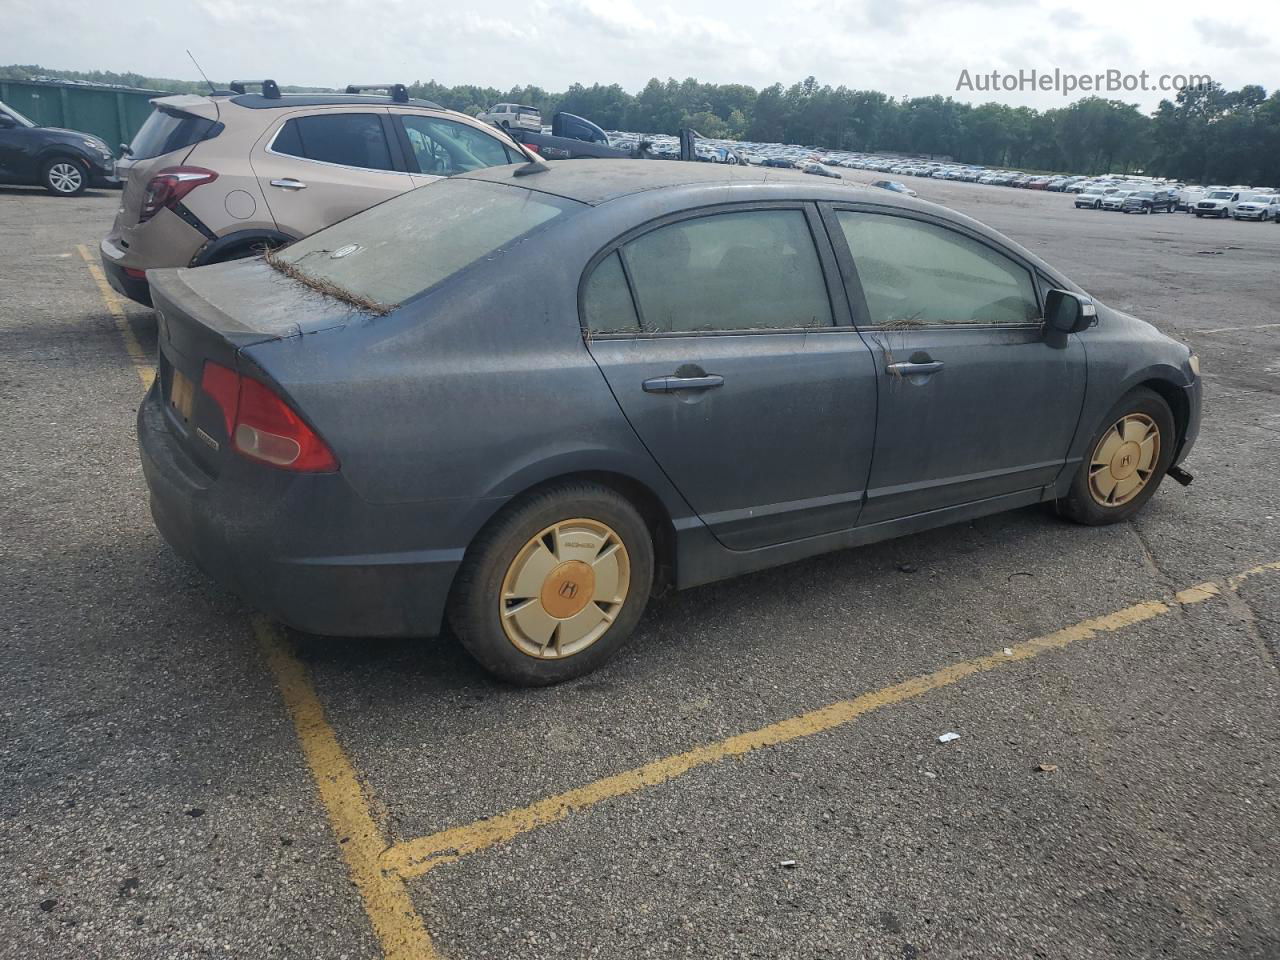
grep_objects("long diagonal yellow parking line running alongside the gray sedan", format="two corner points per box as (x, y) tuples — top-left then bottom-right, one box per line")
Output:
(381, 562), (1280, 877)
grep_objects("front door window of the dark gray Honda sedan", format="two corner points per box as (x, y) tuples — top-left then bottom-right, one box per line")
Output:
(837, 210), (1039, 326)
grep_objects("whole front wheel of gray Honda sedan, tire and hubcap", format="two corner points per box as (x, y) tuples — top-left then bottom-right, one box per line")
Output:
(1057, 387), (1176, 526)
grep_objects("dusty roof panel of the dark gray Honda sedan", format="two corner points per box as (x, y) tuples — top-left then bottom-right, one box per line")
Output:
(460, 159), (906, 206)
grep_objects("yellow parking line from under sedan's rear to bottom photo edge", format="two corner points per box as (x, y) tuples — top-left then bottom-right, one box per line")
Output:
(253, 617), (439, 960)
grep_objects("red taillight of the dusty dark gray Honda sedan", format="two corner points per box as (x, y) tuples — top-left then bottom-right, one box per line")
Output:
(200, 361), (338, 474)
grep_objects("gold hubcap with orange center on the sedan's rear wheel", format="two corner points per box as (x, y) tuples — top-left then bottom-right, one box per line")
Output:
(499, 517), (631, 659)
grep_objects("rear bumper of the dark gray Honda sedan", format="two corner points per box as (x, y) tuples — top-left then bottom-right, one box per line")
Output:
(138, 381), (466, 636)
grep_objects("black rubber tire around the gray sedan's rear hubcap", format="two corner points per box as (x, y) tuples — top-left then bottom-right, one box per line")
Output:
(448, 483), (654, 686)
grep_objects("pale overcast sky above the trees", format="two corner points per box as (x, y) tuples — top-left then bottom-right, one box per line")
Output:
(0, 0), (1280, 109)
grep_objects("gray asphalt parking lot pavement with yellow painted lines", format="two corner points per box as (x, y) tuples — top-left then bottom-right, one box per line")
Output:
(0, 174), (1280, 960)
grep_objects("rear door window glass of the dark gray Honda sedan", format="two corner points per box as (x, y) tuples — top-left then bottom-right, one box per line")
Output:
(622, 210), (832, 333)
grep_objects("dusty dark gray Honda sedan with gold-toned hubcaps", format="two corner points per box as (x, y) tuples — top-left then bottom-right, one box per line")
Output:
(138, 160), (1201, 684)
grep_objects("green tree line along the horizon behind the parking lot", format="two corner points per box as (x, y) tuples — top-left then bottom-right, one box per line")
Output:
(0, 65), (1280, 186)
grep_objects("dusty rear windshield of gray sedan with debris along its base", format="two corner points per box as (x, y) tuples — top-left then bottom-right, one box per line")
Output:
(271, 179), (581, 308)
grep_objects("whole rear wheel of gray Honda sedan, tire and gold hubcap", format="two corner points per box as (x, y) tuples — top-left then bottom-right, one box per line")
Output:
(448, 483), (654, 686)
